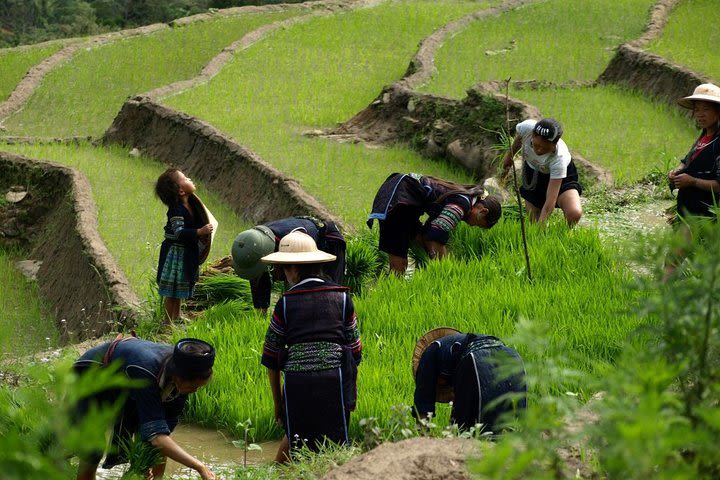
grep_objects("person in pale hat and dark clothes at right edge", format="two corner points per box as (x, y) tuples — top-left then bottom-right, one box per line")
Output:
(668, 83), (720, 217)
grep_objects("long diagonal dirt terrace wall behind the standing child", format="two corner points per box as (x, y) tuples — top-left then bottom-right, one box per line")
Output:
(102, 96), (339, 228)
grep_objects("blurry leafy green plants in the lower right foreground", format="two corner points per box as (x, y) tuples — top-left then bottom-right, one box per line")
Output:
(473, 216), (720, 480)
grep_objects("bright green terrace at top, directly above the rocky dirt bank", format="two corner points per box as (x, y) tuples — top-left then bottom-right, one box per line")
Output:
(421, 0), (656, 98)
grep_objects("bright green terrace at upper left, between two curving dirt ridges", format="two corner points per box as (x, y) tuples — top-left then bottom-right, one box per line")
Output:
(5, 10), (297, 137)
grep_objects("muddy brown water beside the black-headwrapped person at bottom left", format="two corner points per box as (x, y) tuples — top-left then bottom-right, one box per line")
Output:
(97, 425), (279, 480)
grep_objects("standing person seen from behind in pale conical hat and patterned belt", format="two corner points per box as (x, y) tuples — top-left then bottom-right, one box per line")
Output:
(261, 231), (362, 462)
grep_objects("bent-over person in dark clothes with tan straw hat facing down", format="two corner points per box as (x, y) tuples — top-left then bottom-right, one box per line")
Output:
(413, 327), (527, 433)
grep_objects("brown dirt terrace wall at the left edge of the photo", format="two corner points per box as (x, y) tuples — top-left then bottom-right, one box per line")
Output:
(0, 152), (139, 341)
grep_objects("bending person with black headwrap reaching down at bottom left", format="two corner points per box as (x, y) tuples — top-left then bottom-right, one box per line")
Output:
(74, 337), (215, 480)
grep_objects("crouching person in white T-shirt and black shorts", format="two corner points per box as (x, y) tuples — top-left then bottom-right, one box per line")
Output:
(503, 118), (582, 226)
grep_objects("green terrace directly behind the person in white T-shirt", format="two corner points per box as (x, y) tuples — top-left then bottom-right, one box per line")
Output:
(511, 86), (697, 184)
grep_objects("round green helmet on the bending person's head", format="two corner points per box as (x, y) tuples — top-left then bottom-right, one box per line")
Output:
(232, 225), (275, 280)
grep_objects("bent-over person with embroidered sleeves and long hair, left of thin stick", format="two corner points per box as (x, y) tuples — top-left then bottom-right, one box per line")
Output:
(367, 173), (502, 276)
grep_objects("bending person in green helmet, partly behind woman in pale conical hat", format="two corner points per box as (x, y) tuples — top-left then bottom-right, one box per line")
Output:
(232, 216), (346, 311)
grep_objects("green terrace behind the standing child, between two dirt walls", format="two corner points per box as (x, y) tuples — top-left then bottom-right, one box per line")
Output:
(0, 144), (248, 298)
